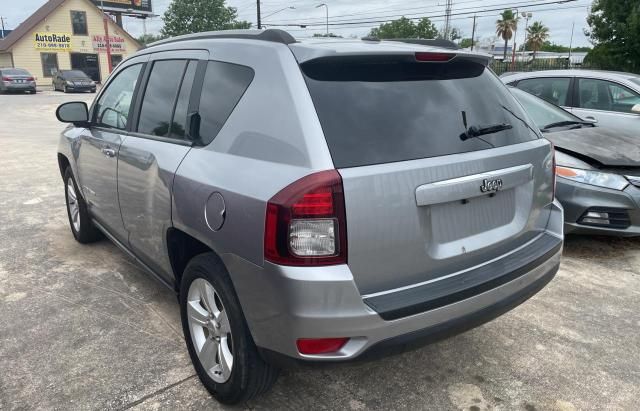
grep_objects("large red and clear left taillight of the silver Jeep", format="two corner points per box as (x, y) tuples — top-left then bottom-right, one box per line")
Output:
(264, 170), (347, 266)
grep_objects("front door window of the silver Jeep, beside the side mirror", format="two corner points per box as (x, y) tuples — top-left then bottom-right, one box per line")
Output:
(94, 64), (142, 130)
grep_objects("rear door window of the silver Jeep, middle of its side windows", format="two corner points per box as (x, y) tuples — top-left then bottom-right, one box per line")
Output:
(138, 60), (187, 137)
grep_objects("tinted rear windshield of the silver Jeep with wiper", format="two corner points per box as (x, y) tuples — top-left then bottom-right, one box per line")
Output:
(301, 57), (539, 168)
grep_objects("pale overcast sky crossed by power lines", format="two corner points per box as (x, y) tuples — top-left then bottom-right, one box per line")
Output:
(0, 0), (592, 46)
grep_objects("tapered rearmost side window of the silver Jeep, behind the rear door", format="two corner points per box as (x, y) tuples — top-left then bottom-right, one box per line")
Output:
(200, 61), (254, 144)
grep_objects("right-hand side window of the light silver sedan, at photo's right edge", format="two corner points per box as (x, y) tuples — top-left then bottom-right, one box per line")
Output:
(578, 79), (640, 113)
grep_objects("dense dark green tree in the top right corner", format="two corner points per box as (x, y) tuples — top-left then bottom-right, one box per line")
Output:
(585, 0), (640, 73)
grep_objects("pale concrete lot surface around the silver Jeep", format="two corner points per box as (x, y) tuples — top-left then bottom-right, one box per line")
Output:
(0, 91), (640, 411)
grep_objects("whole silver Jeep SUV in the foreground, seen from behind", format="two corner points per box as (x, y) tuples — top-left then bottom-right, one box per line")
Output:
(57, 30), (563, 403)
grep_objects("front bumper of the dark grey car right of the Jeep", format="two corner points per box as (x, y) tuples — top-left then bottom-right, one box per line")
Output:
(556, 178), (640, 237)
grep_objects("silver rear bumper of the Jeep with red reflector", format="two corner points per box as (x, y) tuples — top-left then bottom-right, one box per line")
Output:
(223, 204), (563, 365)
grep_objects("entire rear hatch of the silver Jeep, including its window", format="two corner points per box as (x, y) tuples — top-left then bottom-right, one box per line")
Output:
(301, 53), (553, 295)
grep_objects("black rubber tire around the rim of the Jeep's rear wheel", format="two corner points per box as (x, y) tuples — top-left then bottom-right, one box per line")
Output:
(179, 253), (279, 404)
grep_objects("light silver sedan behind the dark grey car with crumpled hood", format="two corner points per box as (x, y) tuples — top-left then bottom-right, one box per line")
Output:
(501, 70), (640, 133)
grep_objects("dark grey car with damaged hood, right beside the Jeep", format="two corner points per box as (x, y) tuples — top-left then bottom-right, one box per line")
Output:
(512, 88), (640, 237)
